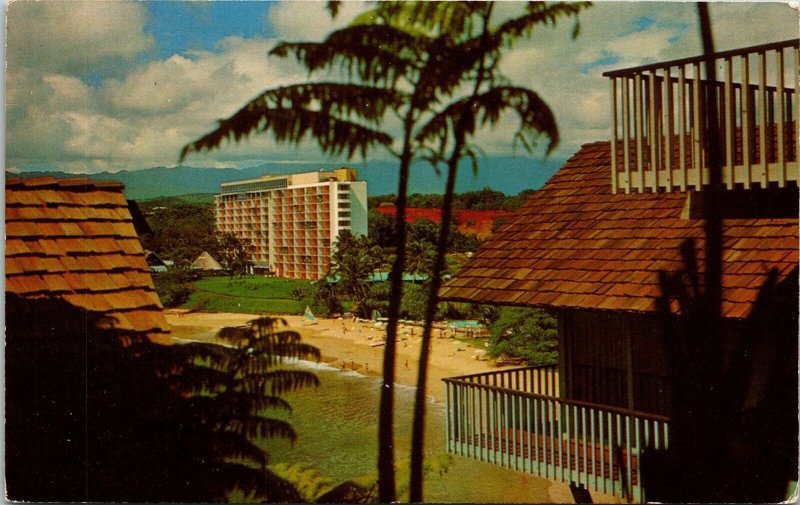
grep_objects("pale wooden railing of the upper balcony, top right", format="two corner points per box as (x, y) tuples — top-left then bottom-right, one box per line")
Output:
(603, 40), (800, 193)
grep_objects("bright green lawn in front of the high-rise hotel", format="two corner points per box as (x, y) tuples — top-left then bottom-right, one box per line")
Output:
(183, 277), (310, 315)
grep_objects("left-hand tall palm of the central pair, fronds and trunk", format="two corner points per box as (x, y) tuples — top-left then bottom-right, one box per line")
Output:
(180, 4), (528, 496)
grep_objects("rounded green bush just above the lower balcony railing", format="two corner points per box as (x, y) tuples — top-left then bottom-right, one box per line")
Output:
(489, 307), (558, 366)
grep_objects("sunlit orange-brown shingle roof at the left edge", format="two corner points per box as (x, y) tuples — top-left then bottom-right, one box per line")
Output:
(6, 177), (171, 343)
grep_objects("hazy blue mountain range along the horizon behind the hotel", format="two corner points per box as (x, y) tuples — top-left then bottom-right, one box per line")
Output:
(6, 156), (564, 200)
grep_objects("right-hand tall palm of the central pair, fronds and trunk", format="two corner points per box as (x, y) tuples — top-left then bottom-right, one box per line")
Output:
(366, 2), (586, 502)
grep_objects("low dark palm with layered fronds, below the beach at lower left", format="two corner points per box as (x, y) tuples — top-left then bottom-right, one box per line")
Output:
(170, 317), (320, 501)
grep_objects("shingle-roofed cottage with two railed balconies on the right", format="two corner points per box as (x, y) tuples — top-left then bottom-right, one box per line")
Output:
(442, 41), (800, 501)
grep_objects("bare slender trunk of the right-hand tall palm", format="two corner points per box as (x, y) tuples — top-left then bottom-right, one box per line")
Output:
(409, 127), (464, 503)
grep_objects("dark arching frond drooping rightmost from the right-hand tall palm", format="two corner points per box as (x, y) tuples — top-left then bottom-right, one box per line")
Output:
(417, 86), (559, 154)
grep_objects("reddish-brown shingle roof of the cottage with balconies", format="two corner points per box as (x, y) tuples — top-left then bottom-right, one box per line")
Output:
(442, 142), (798, 318)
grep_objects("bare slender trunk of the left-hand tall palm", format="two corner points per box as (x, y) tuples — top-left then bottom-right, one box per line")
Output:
(378, 112), (414, 503)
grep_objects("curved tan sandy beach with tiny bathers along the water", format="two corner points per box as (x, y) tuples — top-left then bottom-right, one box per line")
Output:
(166, 310), (498, 402)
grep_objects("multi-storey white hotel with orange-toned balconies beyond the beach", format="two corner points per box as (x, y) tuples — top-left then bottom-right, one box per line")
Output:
(214, 168), (367, 279)
